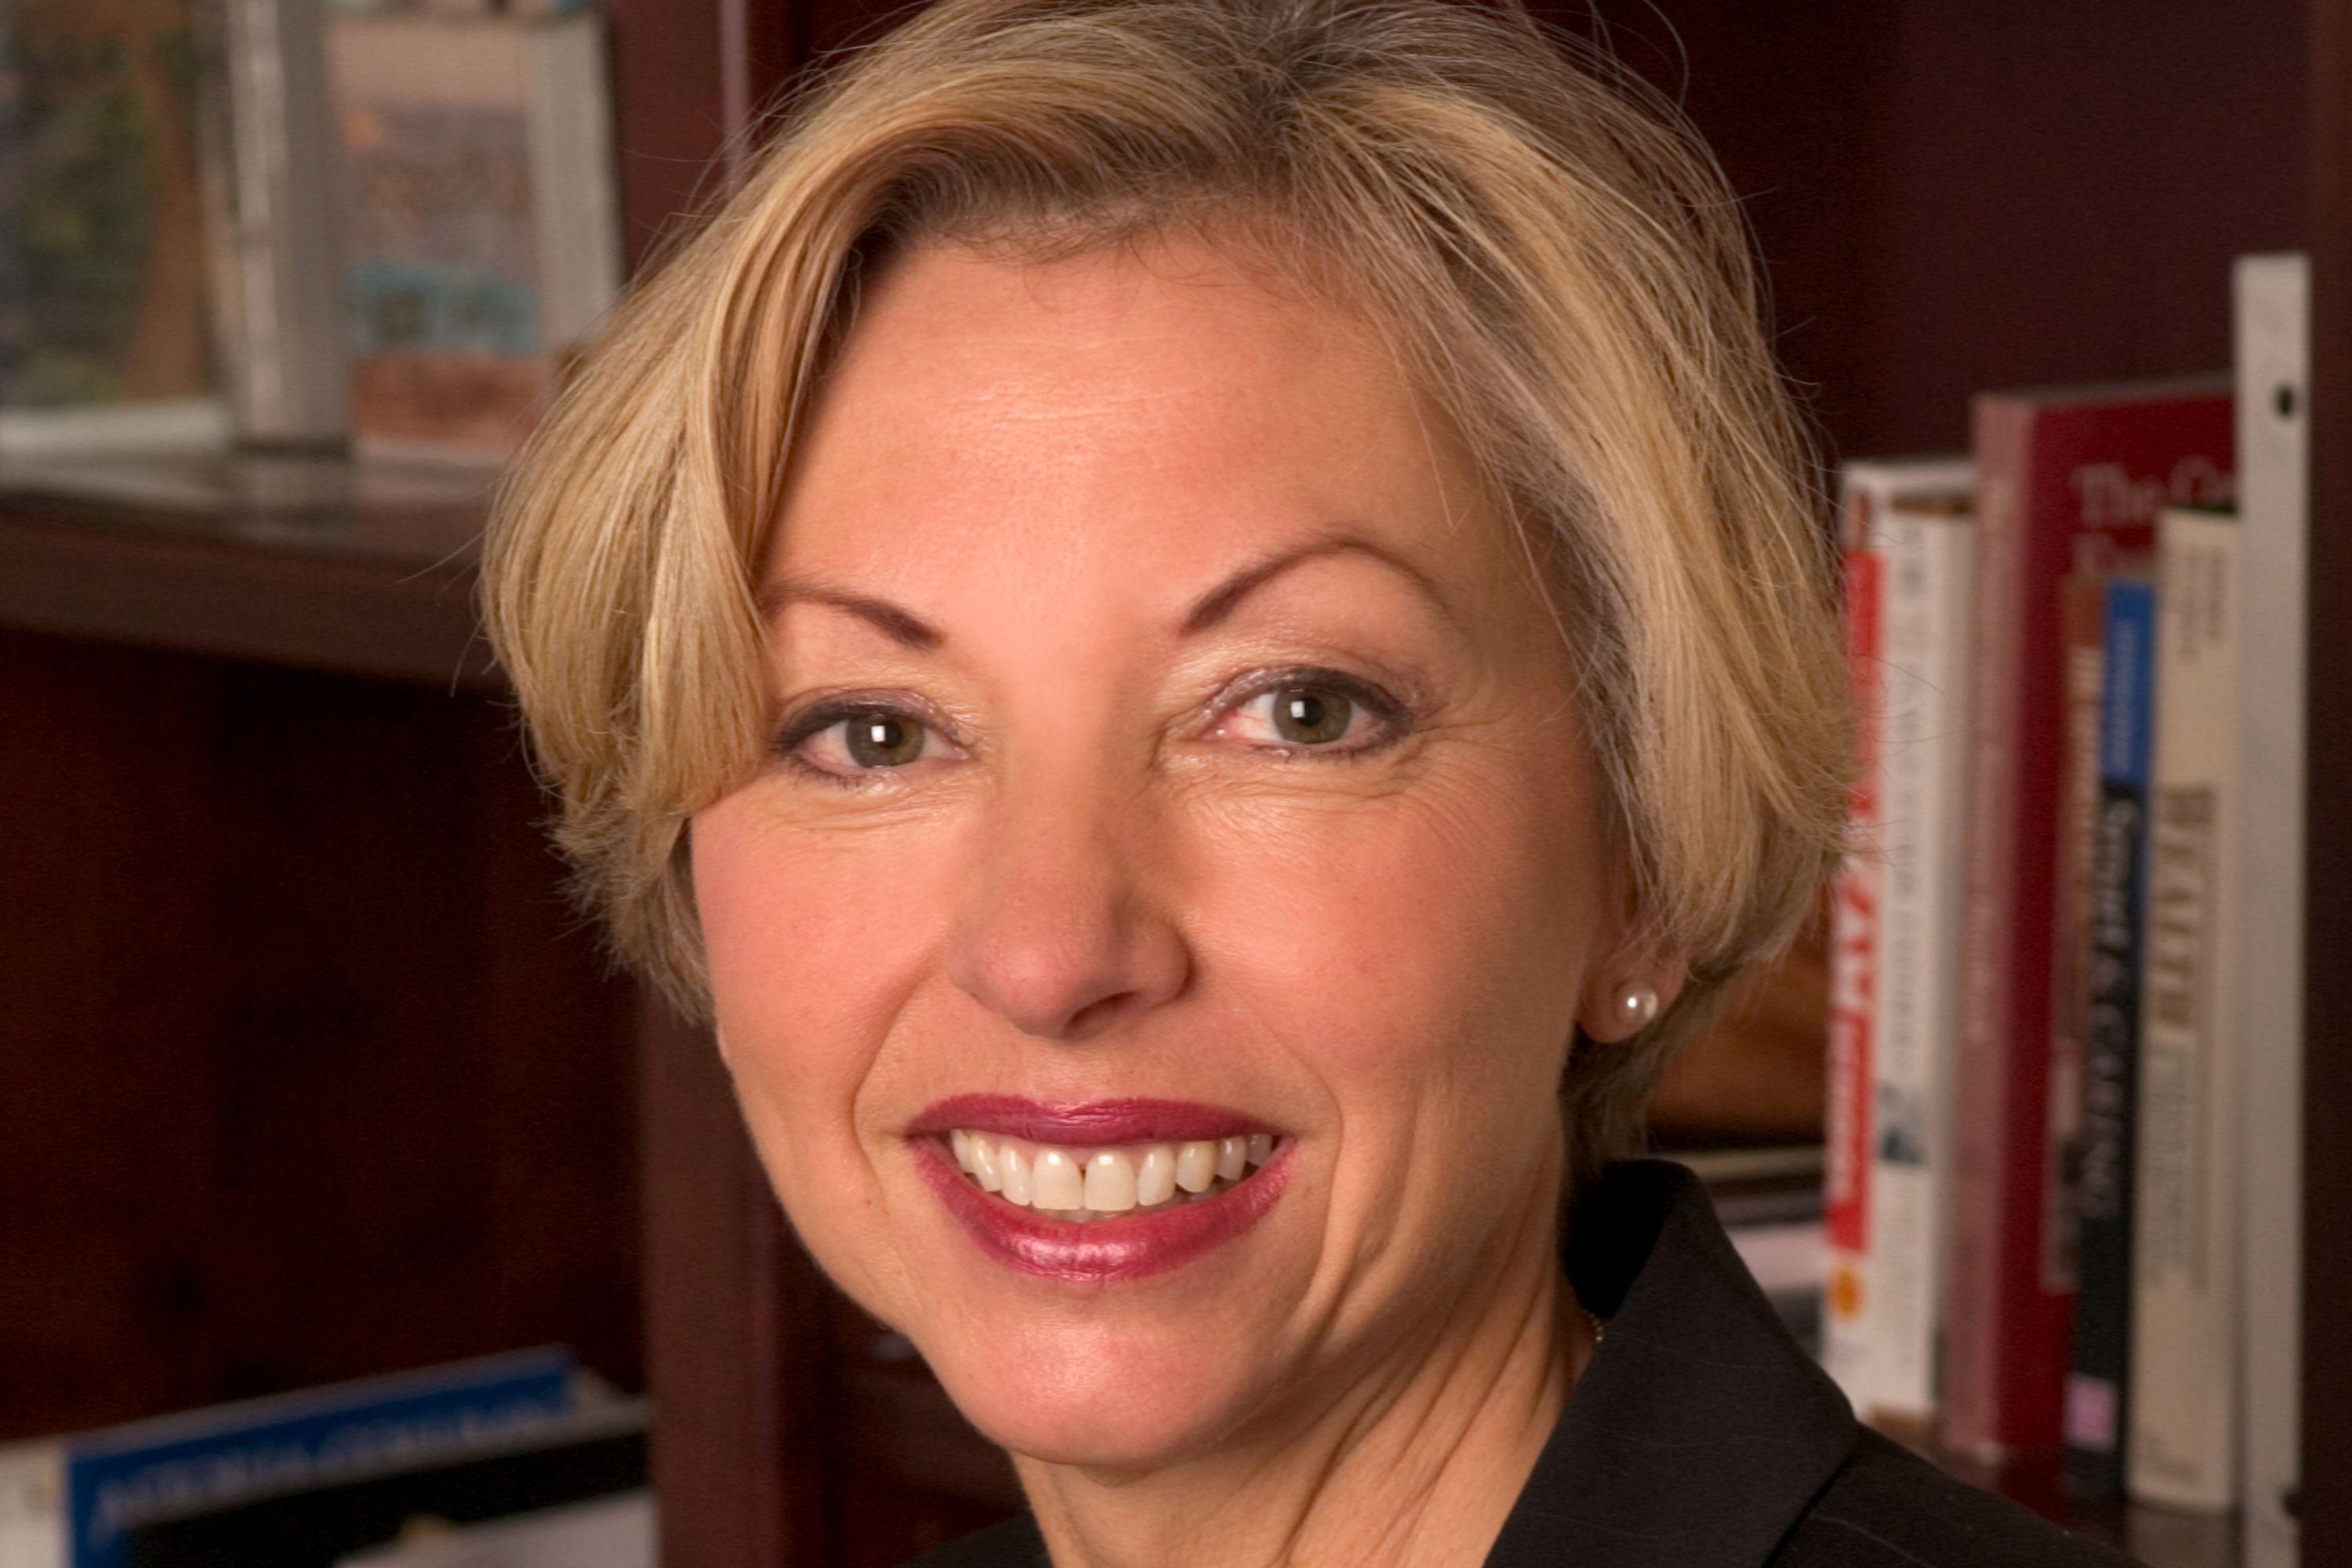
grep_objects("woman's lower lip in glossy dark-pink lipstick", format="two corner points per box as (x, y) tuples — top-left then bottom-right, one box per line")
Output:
(915, 1138), (1291, 1283)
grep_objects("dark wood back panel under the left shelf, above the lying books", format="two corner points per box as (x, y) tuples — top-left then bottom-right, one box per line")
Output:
(0, 630), (642, 1436)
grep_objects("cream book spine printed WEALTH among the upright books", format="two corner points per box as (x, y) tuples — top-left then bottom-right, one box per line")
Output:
(2129, 510), (2244, 1512)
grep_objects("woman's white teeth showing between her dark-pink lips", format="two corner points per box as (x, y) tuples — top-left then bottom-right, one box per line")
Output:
(948, 1128), (1279, 1222)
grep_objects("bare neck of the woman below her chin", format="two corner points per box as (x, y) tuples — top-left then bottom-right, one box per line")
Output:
(1016, 1173), (1592, 1568)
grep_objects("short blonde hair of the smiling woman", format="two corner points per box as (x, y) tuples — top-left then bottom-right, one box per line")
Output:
(485, 0), (1853, 1175)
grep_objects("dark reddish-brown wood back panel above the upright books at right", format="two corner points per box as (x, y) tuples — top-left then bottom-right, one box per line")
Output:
(1538, 0), (2312, 456)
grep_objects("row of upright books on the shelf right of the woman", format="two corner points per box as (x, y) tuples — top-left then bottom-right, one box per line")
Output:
(1823, 256), (2307, 1568)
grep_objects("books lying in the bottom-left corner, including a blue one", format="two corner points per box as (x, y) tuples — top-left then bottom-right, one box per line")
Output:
(0, 1349), (654, 1568)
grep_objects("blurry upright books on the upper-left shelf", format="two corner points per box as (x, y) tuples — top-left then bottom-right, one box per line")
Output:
(0, 0), (621, 482)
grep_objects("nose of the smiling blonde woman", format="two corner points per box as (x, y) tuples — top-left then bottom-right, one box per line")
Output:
(948, 779), (1192, 1041)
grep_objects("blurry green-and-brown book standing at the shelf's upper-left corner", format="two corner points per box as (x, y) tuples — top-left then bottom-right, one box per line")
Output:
(0, 0), (228, 466)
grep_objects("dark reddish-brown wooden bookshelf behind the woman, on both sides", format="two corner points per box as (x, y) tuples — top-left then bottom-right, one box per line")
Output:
(0, 0), (2352, 1568)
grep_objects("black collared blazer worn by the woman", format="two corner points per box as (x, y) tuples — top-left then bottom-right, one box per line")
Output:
(894, 1159), (2129, 1568)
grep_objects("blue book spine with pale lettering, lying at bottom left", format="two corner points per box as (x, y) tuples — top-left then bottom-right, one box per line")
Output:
(66, 1349), (574, 1568)
